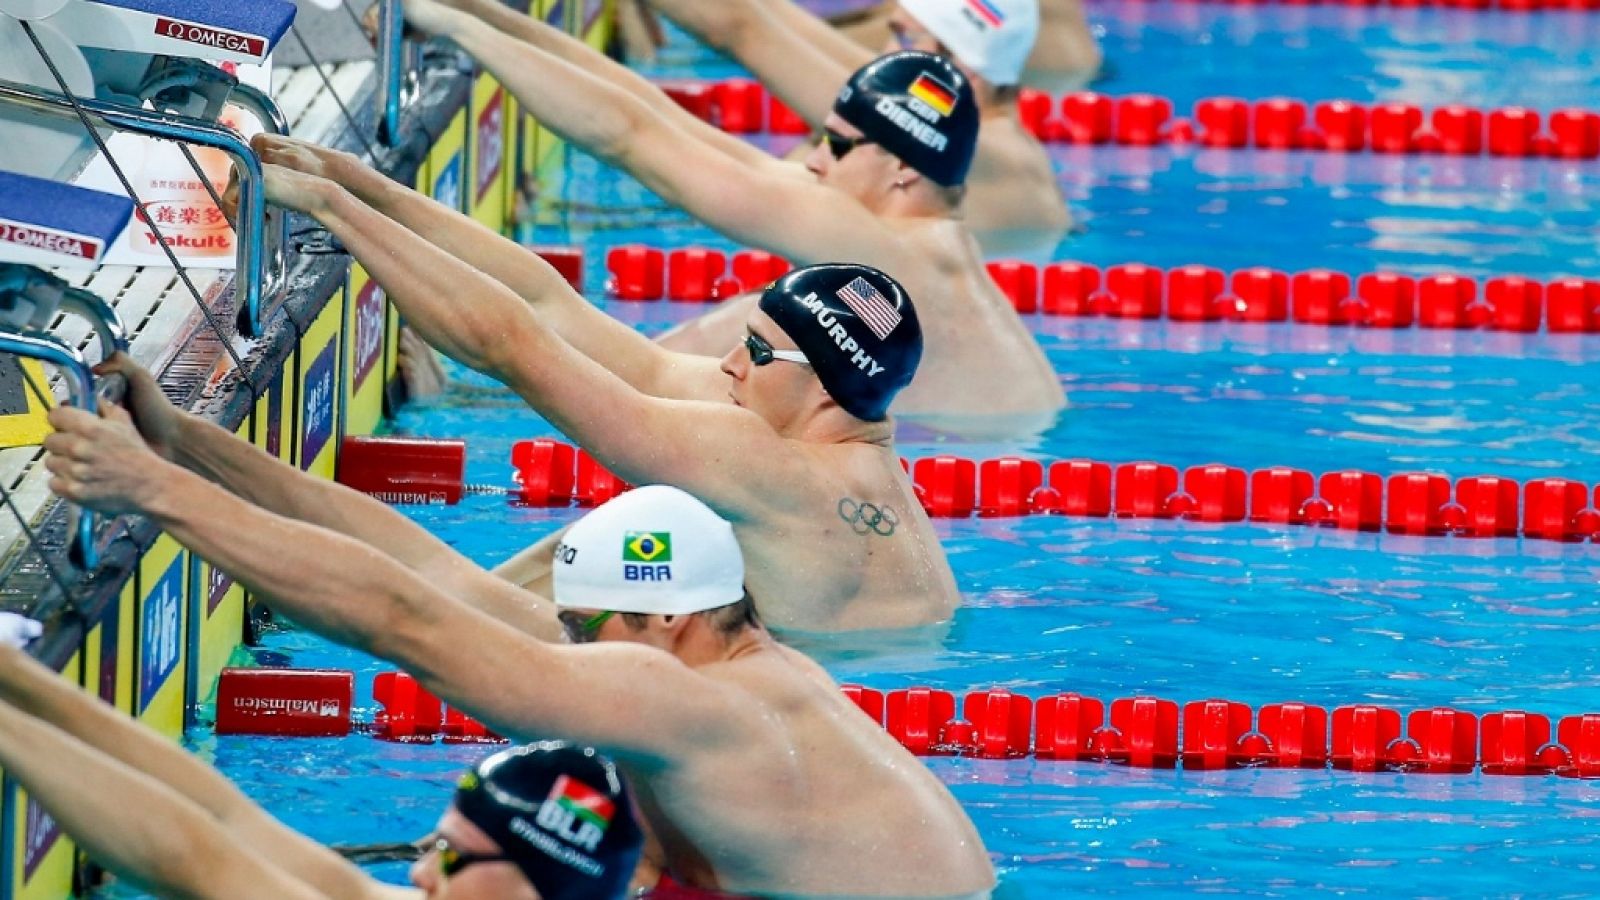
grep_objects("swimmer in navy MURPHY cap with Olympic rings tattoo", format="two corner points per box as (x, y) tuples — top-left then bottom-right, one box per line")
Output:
(235, 153), (960, 631)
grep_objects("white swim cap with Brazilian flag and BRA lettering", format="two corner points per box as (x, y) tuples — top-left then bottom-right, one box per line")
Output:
(554, 485), (744, 615)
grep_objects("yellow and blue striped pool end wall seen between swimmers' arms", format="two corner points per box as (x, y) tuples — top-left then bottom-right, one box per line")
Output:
(0, 0), (611, 900)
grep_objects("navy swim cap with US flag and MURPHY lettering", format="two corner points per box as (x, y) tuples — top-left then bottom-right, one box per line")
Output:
(760, 263), (922, 421)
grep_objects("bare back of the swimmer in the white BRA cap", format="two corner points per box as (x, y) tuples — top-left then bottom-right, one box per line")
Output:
(640, 644), (994, 897)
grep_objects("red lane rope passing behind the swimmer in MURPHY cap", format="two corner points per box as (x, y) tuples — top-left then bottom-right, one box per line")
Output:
(338, 437), (1600, 541)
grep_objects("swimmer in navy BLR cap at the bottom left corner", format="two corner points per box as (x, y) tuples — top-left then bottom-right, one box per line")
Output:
(0, 613), (643, 900)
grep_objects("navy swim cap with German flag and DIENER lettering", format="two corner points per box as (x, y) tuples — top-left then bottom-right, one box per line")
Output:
(834, 50), (978, 187)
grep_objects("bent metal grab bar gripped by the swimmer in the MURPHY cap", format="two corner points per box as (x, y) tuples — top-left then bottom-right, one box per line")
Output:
(0, 80), (286, 338)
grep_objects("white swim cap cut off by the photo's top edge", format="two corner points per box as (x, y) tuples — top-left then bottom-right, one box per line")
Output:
(899, 0), (1038, 86)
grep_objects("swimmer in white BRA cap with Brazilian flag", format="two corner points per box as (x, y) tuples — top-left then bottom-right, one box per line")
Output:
(46, 389), (994, 897)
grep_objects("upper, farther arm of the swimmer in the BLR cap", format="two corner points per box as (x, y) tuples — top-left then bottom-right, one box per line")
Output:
(0, 647), (390, 897)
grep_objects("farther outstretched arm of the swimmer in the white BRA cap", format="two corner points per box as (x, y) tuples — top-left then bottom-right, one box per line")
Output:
(101, 356), (562, 641)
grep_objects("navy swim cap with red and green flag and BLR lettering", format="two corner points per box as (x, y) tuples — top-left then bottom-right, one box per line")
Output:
(456, 741), (645, 900)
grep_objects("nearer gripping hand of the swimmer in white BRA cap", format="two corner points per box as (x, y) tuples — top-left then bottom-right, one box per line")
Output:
(45, 404), (166, 516)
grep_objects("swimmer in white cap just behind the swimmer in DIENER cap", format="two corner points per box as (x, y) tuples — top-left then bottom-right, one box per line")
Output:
(648, 0), (1072, 243)
